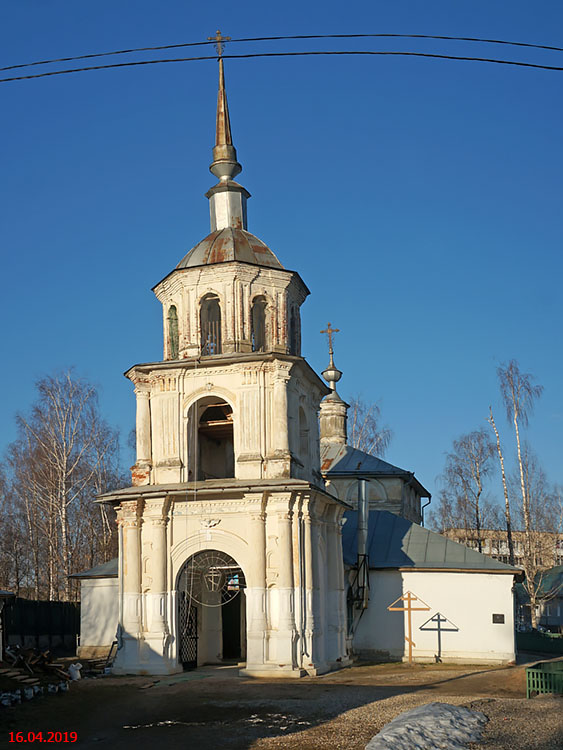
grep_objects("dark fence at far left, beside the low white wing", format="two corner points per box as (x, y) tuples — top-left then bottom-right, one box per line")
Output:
(4, 597), (80, 655)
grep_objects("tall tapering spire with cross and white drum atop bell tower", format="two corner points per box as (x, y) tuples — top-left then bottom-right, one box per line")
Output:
(206, 31), (250, 232)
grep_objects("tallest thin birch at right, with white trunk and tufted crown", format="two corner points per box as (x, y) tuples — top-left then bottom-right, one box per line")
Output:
(497, 359), (543, 628)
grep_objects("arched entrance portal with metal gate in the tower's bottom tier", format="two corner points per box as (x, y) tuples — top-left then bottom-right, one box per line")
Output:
(177, 549), (246, 669)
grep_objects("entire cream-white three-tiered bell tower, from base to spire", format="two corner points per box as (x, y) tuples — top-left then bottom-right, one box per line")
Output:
(101, 60), (348, 677)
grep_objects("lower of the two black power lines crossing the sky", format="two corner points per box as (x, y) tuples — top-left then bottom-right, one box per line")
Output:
(0, 50), (563, 83)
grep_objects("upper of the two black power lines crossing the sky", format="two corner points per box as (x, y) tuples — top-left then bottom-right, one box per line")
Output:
(0, 33), (563, 71)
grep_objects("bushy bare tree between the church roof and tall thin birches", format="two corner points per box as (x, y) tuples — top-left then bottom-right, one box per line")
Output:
(442, 429), (494, 552)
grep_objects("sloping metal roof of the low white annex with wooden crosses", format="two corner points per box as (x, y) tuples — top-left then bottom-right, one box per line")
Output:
(342, 510), (520, 573)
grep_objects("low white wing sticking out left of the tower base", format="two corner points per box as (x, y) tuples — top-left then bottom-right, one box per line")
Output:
(70, 557), (119, 659)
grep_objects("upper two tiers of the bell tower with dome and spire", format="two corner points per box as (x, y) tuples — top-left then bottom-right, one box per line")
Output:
(127, 58), (326, 485)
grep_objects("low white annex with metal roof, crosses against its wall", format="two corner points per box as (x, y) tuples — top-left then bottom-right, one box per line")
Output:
(343, 511), (518, 664)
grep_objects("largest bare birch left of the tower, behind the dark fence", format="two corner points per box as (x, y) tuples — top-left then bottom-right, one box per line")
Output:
(1, 372), (125, 599)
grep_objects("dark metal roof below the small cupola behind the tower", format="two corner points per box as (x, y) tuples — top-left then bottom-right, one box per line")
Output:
(321, 443), (430, 497)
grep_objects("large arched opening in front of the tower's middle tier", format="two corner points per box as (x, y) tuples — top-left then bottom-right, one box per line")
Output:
(188, 396), (235, 481)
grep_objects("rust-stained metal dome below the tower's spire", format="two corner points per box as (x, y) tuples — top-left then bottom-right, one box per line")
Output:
(176, 227), (283, 268)
